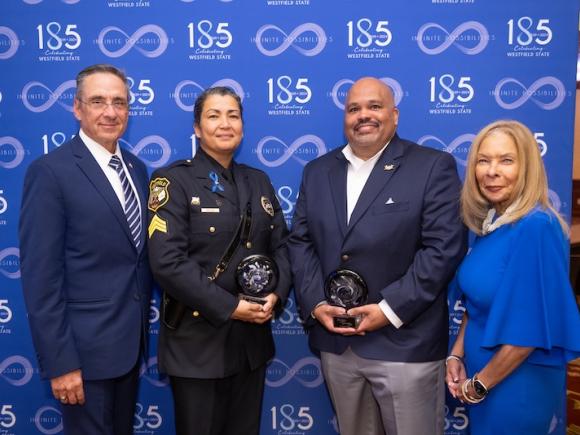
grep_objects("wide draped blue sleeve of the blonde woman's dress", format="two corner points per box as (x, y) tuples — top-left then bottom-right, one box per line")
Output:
(482, 211), (580, 365)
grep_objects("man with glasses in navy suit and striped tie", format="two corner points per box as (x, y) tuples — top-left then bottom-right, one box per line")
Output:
(20, 64), (152, 435)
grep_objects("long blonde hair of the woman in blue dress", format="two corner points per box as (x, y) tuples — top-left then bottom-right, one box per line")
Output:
(461, 120), (568, 235)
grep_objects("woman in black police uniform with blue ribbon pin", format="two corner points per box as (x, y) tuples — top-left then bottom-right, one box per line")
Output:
(149, 87), (291, 435)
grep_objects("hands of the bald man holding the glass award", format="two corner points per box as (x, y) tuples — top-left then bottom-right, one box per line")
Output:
(312, 304), (389, 335)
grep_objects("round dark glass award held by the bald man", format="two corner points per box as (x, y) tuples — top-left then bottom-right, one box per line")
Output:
(324, 269), (368, 328)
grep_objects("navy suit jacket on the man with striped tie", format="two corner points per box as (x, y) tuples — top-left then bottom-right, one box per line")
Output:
(20, 136), (151, 380)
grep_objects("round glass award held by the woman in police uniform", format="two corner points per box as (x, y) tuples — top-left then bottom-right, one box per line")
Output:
(236, 254), (279, 305)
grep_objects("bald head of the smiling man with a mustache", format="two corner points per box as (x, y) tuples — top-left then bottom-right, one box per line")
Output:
(344, 77), (399, 160)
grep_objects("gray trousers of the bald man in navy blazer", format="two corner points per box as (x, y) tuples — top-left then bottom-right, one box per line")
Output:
(321, 348), (445, 435)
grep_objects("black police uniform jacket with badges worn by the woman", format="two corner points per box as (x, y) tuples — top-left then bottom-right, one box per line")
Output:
(149, 151), (291, 378)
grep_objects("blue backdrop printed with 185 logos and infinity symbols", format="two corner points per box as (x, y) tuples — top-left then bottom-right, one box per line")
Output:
(0, 0), (578, 435)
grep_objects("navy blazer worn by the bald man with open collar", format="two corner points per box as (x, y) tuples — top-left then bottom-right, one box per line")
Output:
(288, 135), (466, 362)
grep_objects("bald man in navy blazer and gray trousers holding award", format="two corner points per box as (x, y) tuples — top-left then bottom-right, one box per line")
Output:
(288, 78), (466, 435)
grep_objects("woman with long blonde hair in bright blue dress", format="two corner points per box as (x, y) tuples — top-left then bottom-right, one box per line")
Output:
(446, 121), (580, 435)
